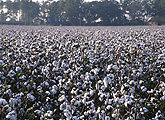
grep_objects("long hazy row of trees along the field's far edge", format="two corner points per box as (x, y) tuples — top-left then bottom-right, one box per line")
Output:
(0, 0), (165, 26)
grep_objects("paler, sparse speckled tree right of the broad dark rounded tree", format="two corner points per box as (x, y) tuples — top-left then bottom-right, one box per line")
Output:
(120, 0), (152, 24)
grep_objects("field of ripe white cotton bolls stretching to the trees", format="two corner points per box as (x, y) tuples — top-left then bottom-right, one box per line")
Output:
(0, 26), (165, 120)
